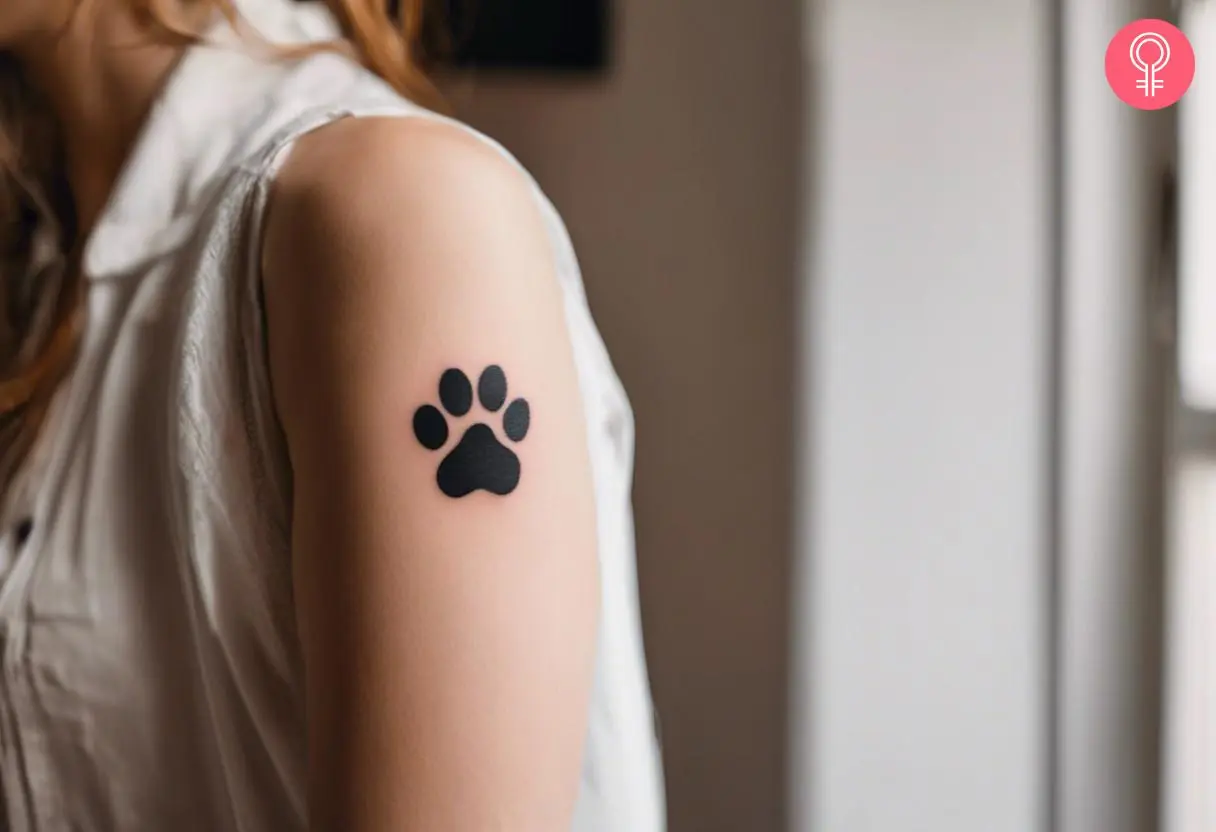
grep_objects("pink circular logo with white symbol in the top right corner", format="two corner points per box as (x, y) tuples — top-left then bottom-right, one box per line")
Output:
(1107, 19), (1195, 109)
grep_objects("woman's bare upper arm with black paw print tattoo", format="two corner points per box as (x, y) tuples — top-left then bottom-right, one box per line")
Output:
(264, 119), (598, 832)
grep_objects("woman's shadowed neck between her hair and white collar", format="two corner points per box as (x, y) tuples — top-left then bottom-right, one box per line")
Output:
(16, 0), (195, 235)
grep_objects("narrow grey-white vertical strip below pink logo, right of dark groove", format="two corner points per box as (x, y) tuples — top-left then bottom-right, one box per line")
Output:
(1047, 0), (1172, 832)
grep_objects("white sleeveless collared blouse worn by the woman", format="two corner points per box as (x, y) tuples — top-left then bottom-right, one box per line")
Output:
(0, 0), (664, 832)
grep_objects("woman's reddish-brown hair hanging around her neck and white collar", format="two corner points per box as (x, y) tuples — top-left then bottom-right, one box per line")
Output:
(0, 0), (438, 489)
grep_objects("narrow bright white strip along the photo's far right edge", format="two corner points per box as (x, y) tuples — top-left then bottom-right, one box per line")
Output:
(1164, 1), (1216, 832)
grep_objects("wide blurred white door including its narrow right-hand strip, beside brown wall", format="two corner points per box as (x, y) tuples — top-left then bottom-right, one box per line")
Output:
(790, 0), (1172, 832)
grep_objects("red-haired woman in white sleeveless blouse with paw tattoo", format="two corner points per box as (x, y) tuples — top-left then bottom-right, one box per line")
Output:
(0, 0), (663, 832)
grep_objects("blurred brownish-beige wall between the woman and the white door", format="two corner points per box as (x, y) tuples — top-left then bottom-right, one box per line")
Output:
(450, 0), (801, 832)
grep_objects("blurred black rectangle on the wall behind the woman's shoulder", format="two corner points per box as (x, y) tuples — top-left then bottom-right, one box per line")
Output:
(446, 0), (609, 73)
